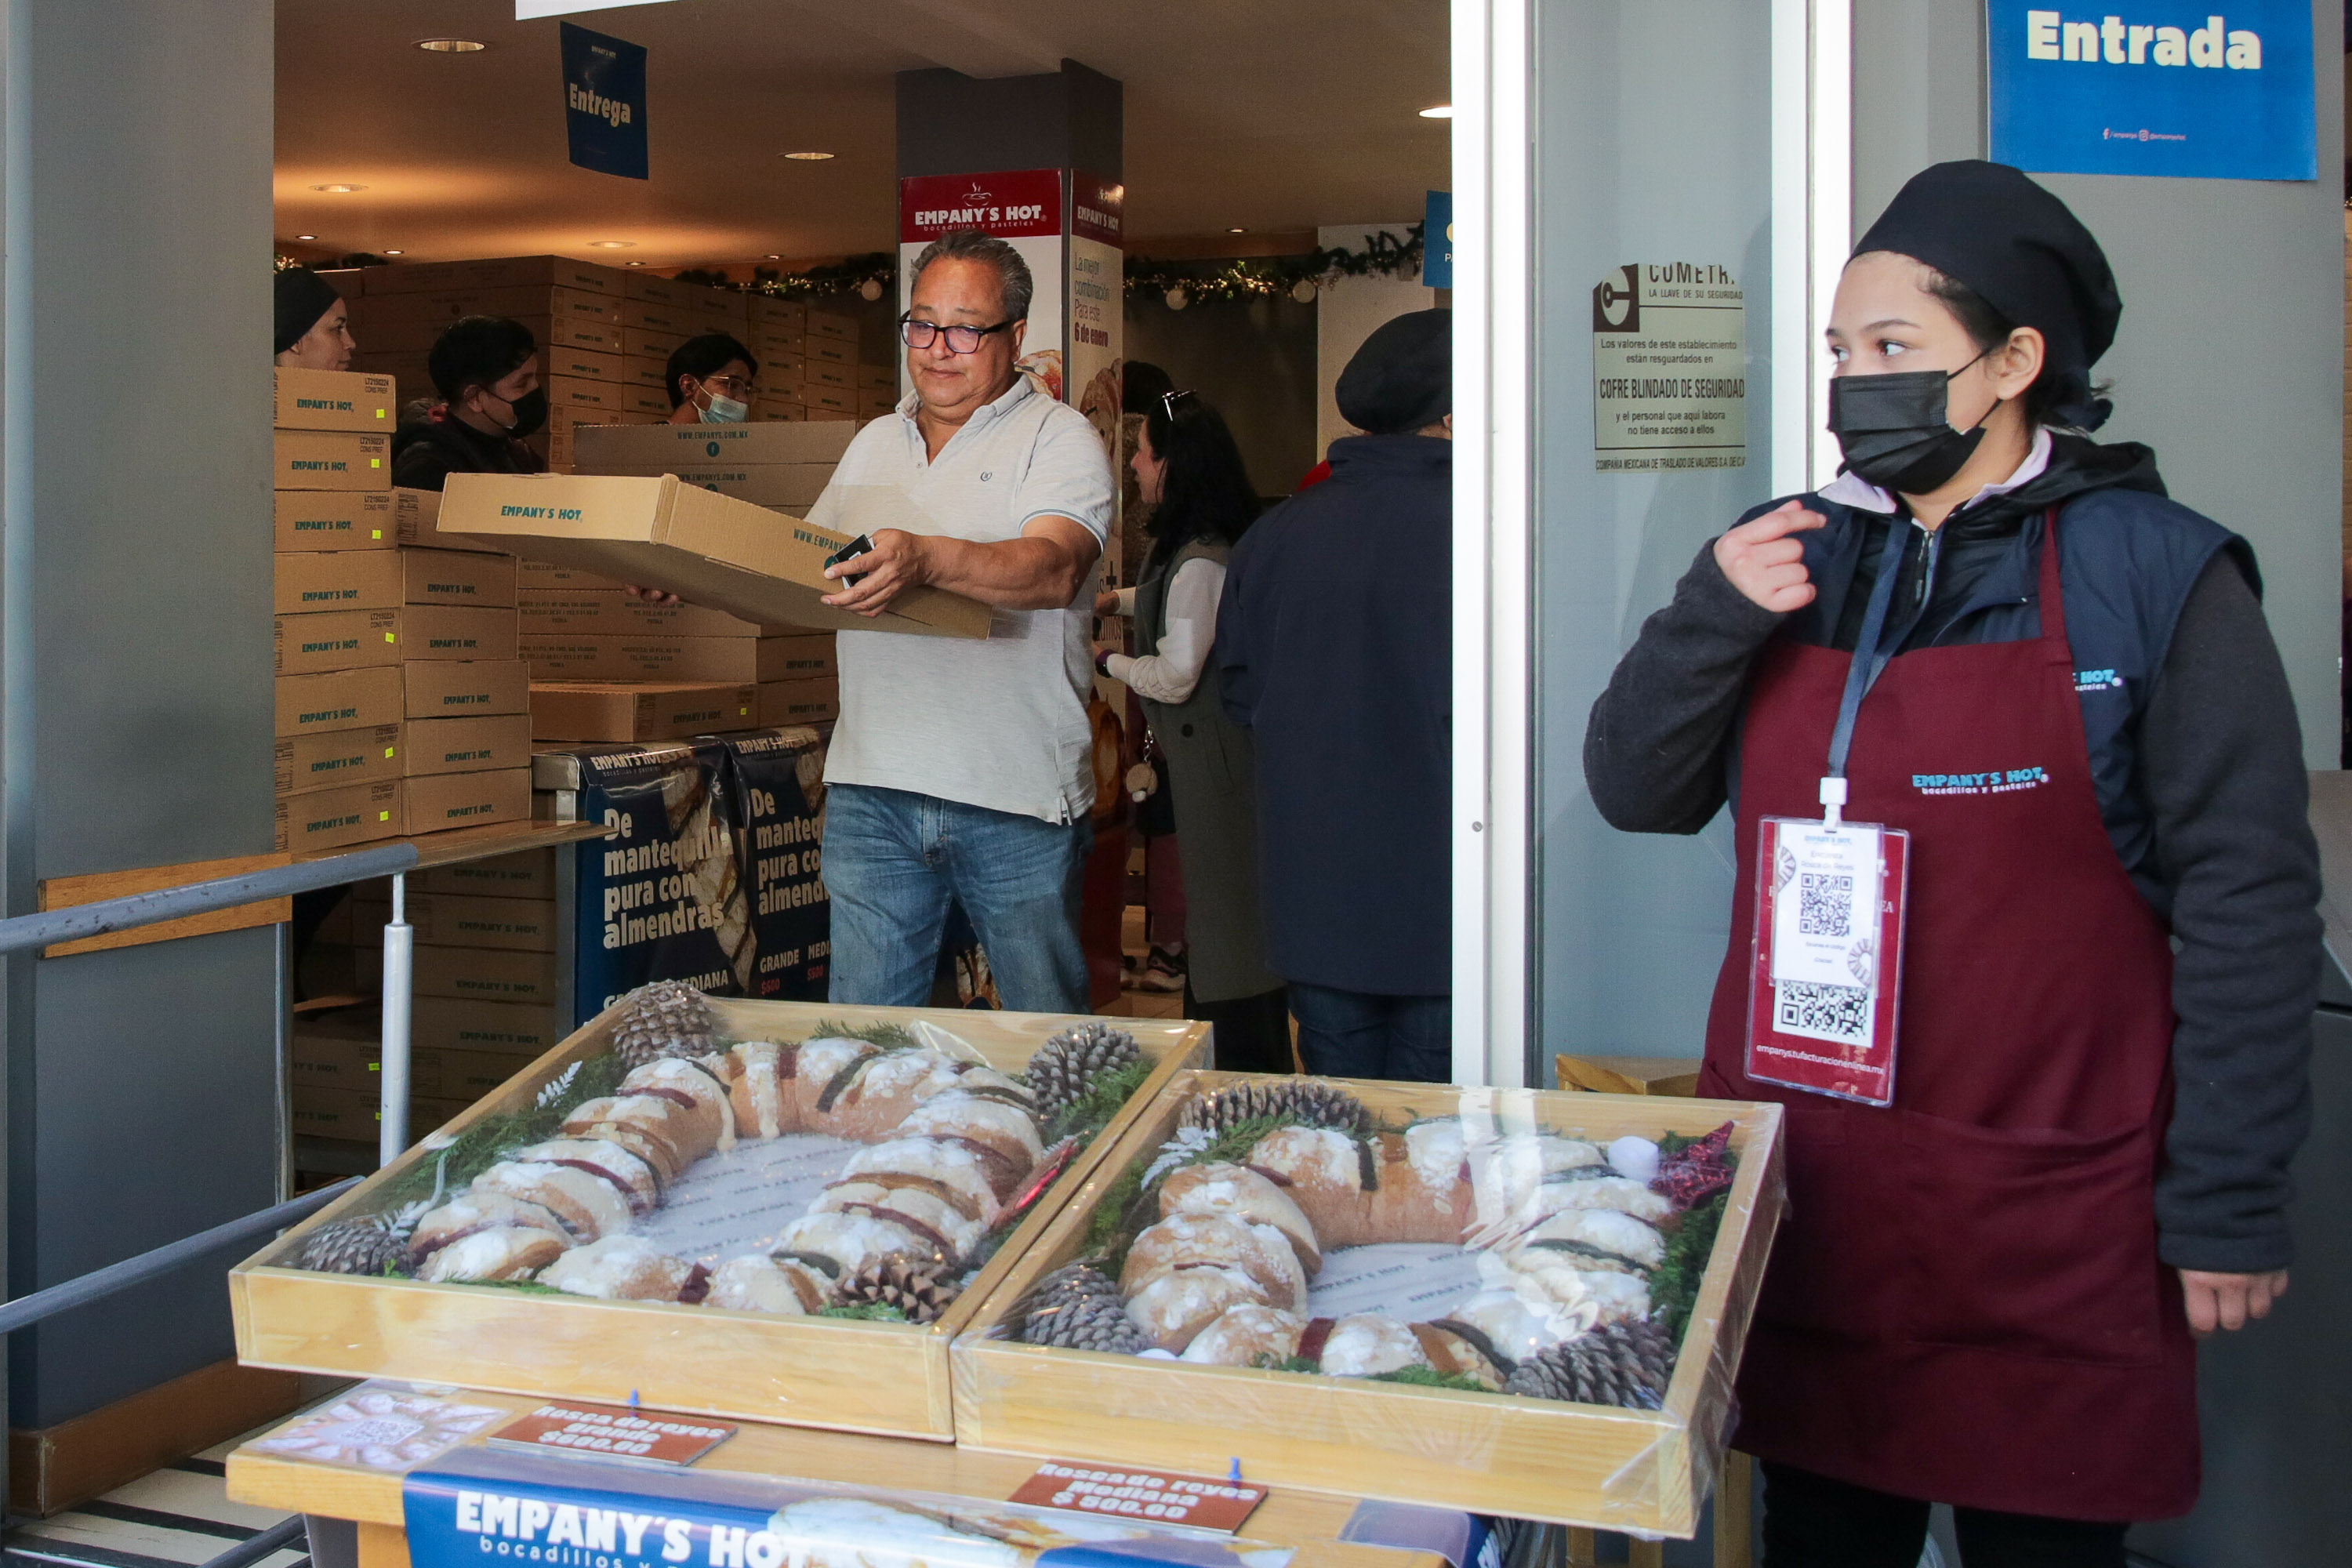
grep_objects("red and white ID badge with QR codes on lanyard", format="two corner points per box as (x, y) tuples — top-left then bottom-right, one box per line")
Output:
(1748, 815), (1910, 1105)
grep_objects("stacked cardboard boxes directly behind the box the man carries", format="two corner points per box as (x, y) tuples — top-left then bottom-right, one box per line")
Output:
(520, 420), (856, 741)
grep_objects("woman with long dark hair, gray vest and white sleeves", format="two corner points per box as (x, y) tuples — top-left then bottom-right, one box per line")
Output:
(1094, 393), (1291, 1072)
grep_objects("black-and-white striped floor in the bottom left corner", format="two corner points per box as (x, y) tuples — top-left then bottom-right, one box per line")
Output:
(0, 1422), (310, 1568)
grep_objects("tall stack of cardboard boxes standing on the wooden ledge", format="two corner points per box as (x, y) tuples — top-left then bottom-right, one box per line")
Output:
(275, 369), (532, 853)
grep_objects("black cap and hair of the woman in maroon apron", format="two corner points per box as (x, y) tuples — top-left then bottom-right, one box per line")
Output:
(1853, 158), (2124, 430)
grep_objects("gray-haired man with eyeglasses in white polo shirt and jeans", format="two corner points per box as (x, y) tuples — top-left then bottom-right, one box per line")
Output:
(809, 233), (1112, 1013)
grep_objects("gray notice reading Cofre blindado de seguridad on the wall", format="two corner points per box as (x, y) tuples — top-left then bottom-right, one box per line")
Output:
(1592, 261), (1748, 473)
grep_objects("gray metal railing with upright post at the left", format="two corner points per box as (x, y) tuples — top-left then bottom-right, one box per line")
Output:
(0, 844), (419, 1568)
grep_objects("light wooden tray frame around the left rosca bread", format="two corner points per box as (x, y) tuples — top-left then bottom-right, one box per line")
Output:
(228, 999), (1209, 1441)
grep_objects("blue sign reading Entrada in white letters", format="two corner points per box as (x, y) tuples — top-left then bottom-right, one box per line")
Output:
(1985, 0), (2319, 179)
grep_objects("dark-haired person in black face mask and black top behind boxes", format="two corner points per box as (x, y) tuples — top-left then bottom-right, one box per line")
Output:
(393, 315), (548, 489)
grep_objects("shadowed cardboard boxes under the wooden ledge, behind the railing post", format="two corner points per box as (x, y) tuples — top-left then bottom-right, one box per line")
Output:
(289, 848), (569, 1173)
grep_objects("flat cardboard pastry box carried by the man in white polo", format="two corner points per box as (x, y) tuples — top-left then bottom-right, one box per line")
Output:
(442, 472), (990, 637)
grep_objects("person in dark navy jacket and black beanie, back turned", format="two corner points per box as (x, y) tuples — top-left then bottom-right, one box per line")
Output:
(1216, 310), (1454, 1083)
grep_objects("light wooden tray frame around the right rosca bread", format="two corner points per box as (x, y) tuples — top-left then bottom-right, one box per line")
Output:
(953, 1072), (1783, 1537)
